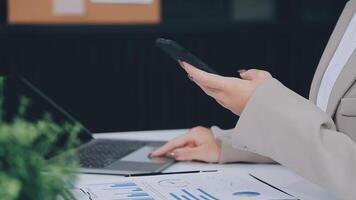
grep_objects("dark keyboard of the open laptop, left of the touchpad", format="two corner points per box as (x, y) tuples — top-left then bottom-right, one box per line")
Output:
(78, 139), (147, 168)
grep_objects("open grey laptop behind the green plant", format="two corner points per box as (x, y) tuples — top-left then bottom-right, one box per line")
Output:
(5, 76), (174, 175)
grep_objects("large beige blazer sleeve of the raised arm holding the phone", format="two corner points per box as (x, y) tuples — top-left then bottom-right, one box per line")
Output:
(231, 79), (356, 200)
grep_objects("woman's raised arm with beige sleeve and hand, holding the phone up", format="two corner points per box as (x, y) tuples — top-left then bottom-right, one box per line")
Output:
(156, 63), (356, 200)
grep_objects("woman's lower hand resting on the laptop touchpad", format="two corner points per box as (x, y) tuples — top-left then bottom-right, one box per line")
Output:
(151, 127), (220, 162)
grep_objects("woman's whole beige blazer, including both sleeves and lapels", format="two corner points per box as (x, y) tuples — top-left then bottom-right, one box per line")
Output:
(212, 0), (356, 200)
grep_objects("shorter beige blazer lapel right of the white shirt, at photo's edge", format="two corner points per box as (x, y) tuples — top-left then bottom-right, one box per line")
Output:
(326, 50), (356, 116)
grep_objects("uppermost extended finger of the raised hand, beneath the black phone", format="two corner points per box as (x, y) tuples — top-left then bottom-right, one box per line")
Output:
(181, 62), (225, 89)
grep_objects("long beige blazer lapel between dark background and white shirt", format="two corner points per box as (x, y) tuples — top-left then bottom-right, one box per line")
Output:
(309, 1), (356, 103)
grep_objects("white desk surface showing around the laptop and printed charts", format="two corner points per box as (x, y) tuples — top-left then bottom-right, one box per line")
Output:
(77, 130), (339, 200)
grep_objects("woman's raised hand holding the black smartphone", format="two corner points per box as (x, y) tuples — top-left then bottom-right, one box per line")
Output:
(179, 62), (272, 115)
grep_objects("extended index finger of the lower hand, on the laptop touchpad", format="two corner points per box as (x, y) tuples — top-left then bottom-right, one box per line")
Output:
(151, 134), (191, 157)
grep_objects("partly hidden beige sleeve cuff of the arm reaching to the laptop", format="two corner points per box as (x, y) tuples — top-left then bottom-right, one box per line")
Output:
(211, 126), (275, 163)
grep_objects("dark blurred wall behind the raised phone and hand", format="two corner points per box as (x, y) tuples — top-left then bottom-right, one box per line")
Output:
(0, 0), (346, 132)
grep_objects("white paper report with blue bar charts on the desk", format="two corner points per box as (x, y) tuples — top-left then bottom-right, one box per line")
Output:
(76, 172), (295, 200)
